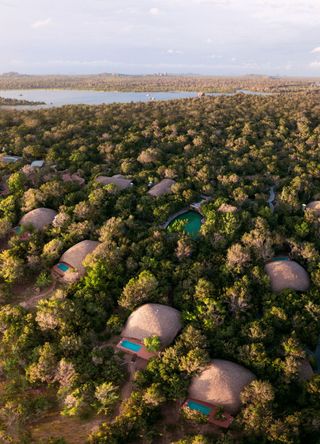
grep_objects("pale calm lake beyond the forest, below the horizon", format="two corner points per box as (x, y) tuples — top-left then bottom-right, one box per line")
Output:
(0, 89), (266, 110)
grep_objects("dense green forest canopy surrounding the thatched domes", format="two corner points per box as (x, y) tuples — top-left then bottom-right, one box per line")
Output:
(0, 89), (320, 444)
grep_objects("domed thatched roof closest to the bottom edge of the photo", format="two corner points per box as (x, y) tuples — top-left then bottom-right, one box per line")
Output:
(189, 359), (255, 415)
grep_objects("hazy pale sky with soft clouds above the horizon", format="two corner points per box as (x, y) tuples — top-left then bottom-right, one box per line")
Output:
(0, 0), (320, 76)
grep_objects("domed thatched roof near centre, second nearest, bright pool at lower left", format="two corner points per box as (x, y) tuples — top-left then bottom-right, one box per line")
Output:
(121, 304), (182, 346)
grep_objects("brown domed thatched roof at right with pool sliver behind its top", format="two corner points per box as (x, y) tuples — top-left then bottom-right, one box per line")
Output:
(265, 260), (310, 291)
